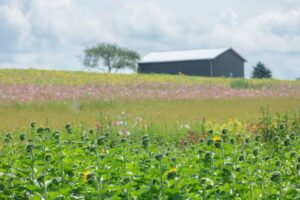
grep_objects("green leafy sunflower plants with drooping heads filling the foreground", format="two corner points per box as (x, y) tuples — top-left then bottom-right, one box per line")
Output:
(0, 112), (300, 199)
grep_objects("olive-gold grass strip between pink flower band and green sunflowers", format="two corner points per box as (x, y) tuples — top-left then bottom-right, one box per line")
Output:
(0, 97), (300, 132)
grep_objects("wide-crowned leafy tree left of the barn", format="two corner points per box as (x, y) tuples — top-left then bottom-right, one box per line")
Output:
(83, 43), (140, 73)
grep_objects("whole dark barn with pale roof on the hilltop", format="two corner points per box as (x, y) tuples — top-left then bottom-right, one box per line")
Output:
(138, 48), (246, 77)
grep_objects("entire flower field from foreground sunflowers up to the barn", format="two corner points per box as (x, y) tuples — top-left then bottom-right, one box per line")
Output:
(0, 70), (300, 199)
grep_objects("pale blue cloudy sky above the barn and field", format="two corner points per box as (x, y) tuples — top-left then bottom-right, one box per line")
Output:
(0, 0), (300, 79)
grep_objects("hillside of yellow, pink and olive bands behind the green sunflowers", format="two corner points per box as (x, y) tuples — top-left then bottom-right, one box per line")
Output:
(0, 69), (300, 130)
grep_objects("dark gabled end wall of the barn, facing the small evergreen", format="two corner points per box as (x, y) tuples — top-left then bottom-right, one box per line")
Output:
(213, 50), (244, 77)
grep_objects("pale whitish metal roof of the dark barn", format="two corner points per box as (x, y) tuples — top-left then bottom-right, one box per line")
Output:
(139, 48), (246, 63)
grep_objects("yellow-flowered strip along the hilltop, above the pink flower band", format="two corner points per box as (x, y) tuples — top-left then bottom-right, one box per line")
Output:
(0, 69), (300, 88)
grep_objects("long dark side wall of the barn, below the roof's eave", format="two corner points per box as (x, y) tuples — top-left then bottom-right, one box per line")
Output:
(138, 60), (210, 76)
